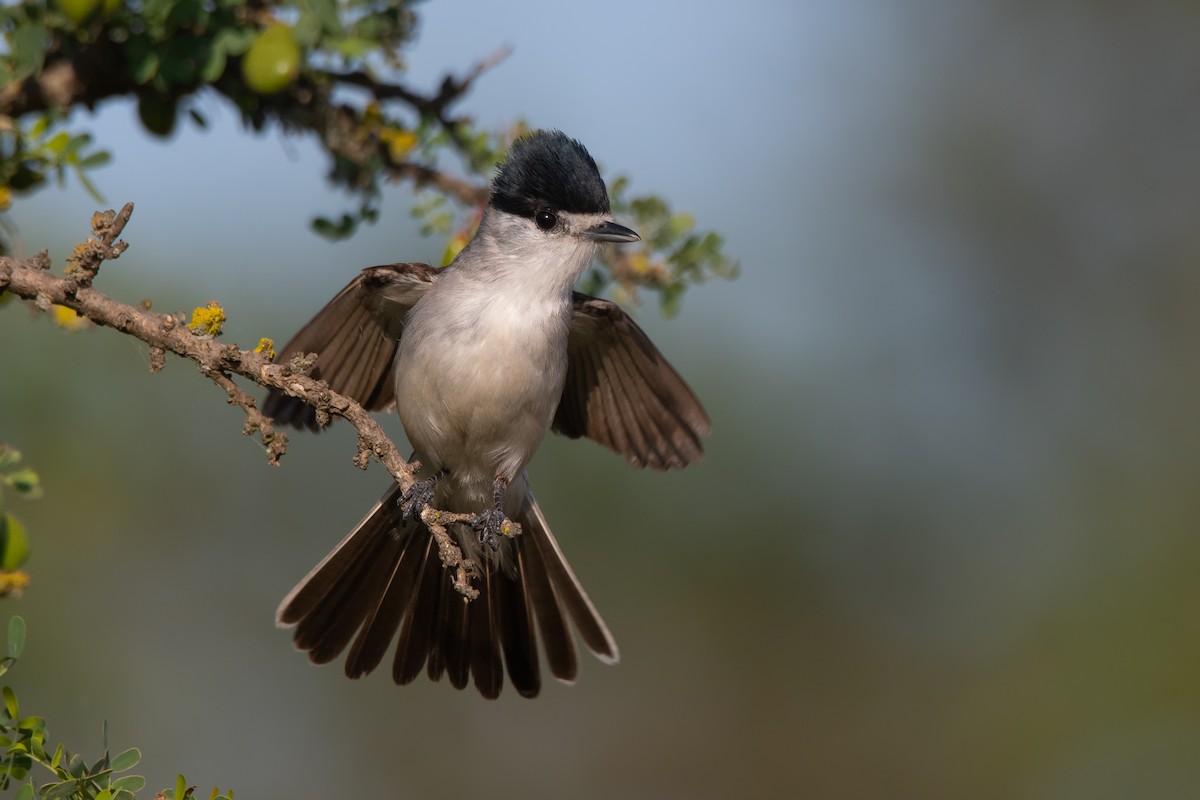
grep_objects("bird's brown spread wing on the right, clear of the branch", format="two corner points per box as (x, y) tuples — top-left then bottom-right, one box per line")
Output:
(553, 291), (712, 469)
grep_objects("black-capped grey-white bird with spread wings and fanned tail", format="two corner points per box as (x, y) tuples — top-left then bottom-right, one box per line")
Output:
(263, 131), (712, 698)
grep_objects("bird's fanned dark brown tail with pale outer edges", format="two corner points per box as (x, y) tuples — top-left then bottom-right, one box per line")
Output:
(276, 486), (618, 698)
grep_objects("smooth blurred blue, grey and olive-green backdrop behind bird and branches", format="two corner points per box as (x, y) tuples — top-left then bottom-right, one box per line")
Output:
(0, 0), (1200, 799)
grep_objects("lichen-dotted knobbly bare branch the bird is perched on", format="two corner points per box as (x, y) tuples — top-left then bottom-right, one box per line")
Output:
(0, 203), (492, 600)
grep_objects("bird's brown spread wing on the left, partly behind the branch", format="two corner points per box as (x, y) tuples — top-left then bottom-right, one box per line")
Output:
(263, 264), (438, 431)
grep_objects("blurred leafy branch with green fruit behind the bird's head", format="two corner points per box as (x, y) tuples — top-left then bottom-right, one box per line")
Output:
(0, 0), (737, 312)
